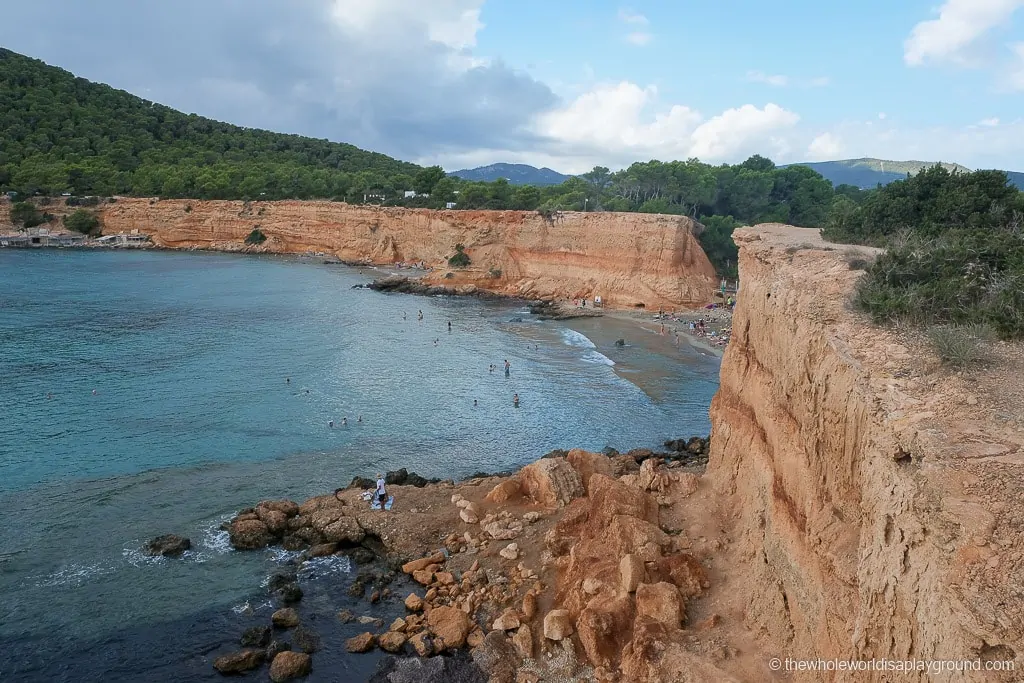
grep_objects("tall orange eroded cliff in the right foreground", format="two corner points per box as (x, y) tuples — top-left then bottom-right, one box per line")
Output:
(706, 225), (1024, 681)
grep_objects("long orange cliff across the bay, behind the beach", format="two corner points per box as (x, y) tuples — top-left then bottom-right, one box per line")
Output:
(94, 199), (716, 308)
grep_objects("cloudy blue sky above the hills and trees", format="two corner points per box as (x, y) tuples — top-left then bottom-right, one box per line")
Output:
(0, 0), (1024, 173)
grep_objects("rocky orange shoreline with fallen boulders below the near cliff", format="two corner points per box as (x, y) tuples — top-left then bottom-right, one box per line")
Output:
(201, 437), (729, 683)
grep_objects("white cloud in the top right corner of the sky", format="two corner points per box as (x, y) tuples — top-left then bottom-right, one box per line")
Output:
(903, 0), (1024, 67)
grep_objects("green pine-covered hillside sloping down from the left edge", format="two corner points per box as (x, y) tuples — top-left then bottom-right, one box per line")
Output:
(0, 48), (423, 200)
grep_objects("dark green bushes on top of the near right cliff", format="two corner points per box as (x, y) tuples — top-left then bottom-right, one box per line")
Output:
(823, 166), (1024, 340)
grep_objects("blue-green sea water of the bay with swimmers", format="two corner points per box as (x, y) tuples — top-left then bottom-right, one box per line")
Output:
(0, 251), (718, 681)
